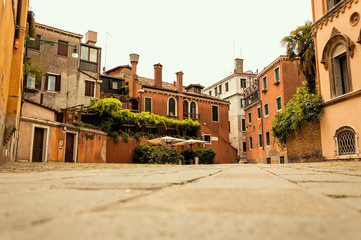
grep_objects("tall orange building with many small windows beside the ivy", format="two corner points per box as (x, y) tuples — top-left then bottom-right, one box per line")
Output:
(243, 56), (305, 164)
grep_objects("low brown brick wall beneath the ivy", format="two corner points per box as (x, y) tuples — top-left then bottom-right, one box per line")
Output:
(287, 121), (323, 163)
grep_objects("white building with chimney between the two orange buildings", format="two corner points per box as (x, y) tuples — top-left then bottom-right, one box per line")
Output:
(202, 59), (257, 161)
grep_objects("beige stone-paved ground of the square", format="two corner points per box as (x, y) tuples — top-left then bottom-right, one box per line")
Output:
(0, 162), (361, 240)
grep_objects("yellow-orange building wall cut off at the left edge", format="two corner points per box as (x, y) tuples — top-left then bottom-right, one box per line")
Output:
(0, 0), (28, 164)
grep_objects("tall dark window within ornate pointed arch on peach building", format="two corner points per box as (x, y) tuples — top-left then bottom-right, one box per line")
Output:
(331, 44), (350, 96)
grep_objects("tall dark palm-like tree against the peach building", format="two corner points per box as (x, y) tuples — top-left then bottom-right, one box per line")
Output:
(281, 21), (316, 93)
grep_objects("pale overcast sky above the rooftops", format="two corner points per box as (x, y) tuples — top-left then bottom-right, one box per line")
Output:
(30, 0), (312, 87)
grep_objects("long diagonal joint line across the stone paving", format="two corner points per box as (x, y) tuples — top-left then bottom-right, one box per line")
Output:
(12, 166), (234, 231)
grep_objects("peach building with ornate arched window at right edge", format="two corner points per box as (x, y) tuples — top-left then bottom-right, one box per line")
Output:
(312, 0), (361, 159)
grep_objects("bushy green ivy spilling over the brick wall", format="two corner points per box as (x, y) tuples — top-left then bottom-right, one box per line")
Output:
(272, 83), (324, 144)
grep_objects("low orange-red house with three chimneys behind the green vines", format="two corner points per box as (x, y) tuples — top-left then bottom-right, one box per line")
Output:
(102, 54), (236, 163)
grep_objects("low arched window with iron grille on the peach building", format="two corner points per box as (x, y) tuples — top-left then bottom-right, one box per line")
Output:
(335, 126), (359, 155)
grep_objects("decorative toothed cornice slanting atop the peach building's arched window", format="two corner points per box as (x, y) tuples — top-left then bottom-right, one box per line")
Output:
(312, 0), (359, 33)
